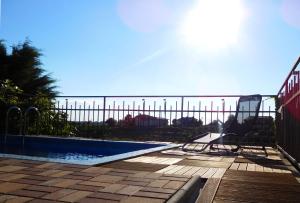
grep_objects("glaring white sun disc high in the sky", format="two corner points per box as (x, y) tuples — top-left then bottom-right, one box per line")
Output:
(179, 0), (245, 50)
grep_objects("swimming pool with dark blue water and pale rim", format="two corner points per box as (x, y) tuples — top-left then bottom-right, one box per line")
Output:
(0, 135), (176, 165)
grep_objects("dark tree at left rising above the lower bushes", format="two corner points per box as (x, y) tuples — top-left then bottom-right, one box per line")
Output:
(0, 40), (57, 98)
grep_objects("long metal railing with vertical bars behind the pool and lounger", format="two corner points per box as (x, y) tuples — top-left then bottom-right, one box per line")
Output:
(54, 95), (275, 127)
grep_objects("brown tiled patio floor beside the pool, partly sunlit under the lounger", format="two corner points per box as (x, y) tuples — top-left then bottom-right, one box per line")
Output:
(0, 145), (300, 203)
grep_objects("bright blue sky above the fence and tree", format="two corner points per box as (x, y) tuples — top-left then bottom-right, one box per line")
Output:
(0, 0), (300, 95)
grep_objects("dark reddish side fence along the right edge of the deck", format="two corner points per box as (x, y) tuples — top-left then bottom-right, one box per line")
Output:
(276, 57), (300, 162)
